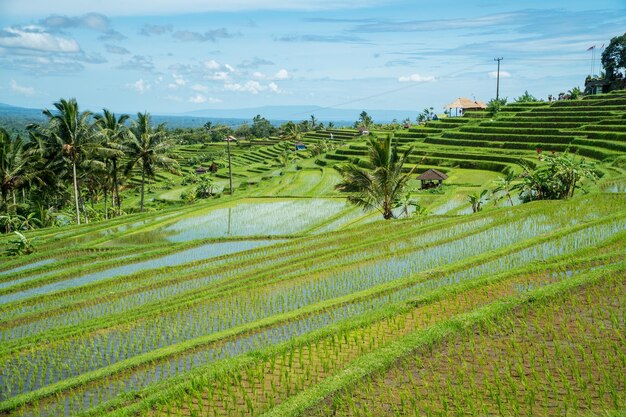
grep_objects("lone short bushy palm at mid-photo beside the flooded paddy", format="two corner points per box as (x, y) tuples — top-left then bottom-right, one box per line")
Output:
(335, 135), (415, 219)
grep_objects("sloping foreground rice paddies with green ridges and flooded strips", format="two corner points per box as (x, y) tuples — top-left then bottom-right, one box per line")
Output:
(0, 193), (626, 416)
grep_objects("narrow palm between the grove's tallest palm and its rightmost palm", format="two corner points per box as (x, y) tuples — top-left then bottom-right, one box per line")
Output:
(95, 109), (129, 215)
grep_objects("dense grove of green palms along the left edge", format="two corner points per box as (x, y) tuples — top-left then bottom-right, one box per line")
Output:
(0, 98), (177, 232)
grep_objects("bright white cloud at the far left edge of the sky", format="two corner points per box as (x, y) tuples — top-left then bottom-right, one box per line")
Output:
(0, 26), (80, 53)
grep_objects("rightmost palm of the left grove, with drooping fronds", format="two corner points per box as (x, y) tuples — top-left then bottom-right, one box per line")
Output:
(125, 112), (176, 212)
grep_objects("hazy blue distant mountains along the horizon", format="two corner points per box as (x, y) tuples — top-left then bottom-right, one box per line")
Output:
(0, 103), (419, 132)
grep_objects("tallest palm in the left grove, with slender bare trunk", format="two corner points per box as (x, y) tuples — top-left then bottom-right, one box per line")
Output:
(43, 98), (94, 224)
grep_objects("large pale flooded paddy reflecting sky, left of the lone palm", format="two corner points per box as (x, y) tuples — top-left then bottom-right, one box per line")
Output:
(116, 198), (346, 243)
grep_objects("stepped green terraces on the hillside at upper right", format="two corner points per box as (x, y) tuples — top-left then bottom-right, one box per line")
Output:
(320, 91), (626, 176)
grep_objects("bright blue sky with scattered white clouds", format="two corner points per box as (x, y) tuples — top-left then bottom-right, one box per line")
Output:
(0, 0), (626, 119)
